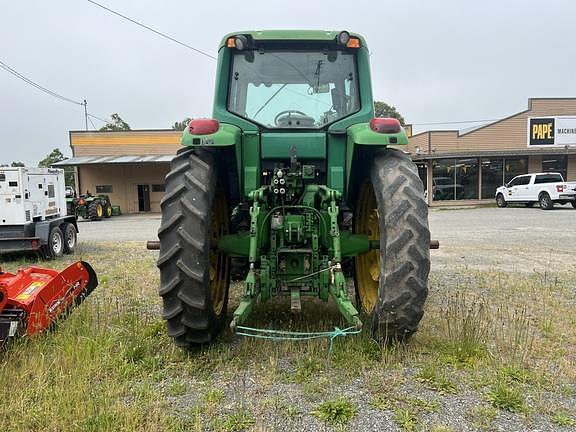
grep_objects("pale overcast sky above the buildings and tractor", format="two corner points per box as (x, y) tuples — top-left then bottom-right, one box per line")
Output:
(0, 0), (576, 165)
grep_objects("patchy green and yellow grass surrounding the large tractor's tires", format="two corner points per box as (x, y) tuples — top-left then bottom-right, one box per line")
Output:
(0, 243), (576, 432)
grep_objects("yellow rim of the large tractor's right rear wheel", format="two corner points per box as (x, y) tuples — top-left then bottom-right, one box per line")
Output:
(355, 182), (380, 312)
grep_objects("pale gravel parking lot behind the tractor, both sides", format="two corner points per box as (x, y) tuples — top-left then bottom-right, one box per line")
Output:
(79, 206), (576, 271)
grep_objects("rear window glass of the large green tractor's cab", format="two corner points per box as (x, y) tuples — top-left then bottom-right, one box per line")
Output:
(228, 50), (360, 128)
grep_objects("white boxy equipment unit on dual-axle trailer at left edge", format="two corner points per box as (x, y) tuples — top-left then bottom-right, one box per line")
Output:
(0, 167), (78, 256)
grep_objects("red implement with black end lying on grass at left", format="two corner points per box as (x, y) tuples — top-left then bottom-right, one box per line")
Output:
(0, 261), (98, 346)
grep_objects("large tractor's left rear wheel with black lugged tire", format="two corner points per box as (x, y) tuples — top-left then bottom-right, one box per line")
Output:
(157, 149), (230, 349)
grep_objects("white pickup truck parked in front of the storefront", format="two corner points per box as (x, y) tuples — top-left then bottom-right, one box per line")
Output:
(496, 172), (576, 210)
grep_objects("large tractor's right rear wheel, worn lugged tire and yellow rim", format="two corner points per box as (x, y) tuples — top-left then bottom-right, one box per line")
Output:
(354, 150), (430, 342)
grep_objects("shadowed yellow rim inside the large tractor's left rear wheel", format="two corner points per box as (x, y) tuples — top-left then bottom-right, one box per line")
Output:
(209, 188), (229, 315)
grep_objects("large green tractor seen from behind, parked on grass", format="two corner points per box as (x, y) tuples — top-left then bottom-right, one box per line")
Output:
(157, 30), (430, 348)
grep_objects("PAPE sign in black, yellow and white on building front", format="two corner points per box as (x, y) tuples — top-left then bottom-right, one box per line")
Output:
(528, 116), (576, 147)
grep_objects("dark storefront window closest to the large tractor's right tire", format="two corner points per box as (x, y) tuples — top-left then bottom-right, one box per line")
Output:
(432, 158), (478, 201)
